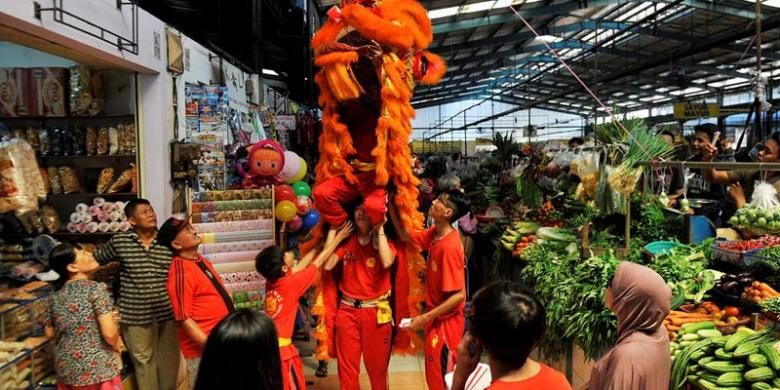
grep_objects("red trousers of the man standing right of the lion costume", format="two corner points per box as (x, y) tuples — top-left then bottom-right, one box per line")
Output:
(425, 313), (465, 390)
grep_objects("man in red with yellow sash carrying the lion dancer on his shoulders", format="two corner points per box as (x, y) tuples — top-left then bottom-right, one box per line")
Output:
(325, 205), (396, 390)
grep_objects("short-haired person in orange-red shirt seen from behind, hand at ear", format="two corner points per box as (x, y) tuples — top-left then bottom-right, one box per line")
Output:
(451, 281), (571, 390)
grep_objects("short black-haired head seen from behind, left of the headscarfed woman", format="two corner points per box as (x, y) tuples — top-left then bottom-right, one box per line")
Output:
(469, 281), (545, 369)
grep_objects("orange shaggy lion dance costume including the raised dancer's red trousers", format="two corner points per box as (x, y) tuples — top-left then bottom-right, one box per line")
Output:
(310, 0), (446, 360)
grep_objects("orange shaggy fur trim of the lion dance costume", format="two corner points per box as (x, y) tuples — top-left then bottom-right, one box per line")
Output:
(310, 0), (446, 360)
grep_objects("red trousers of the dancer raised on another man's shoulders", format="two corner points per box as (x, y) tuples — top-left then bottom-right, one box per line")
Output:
(312, 172), (387, 226)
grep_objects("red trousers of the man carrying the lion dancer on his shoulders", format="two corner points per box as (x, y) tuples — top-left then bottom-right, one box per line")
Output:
(336, 304), (393, 390)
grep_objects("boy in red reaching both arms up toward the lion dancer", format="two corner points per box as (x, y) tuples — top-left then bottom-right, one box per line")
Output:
(255, 223), (352, 390)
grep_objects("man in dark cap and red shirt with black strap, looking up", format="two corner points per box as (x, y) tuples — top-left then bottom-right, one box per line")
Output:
(157, 218), (235, 388)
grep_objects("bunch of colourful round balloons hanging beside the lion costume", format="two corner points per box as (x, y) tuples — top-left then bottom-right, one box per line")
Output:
(274, 156), (320, 233)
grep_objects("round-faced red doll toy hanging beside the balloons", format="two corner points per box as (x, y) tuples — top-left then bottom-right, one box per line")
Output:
(236, 140), (284, 189)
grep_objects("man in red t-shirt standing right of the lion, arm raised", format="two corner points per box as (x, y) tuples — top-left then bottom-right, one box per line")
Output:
(390, 190), (469, 390)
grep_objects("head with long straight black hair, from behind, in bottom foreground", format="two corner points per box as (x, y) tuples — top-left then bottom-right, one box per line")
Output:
(195, 310), (282, 390)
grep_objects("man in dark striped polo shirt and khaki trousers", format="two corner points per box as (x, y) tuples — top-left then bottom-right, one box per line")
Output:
(95, 198), (180, 390)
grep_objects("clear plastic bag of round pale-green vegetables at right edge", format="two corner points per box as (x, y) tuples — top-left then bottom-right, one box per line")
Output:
(729, 181), (780, 234)
